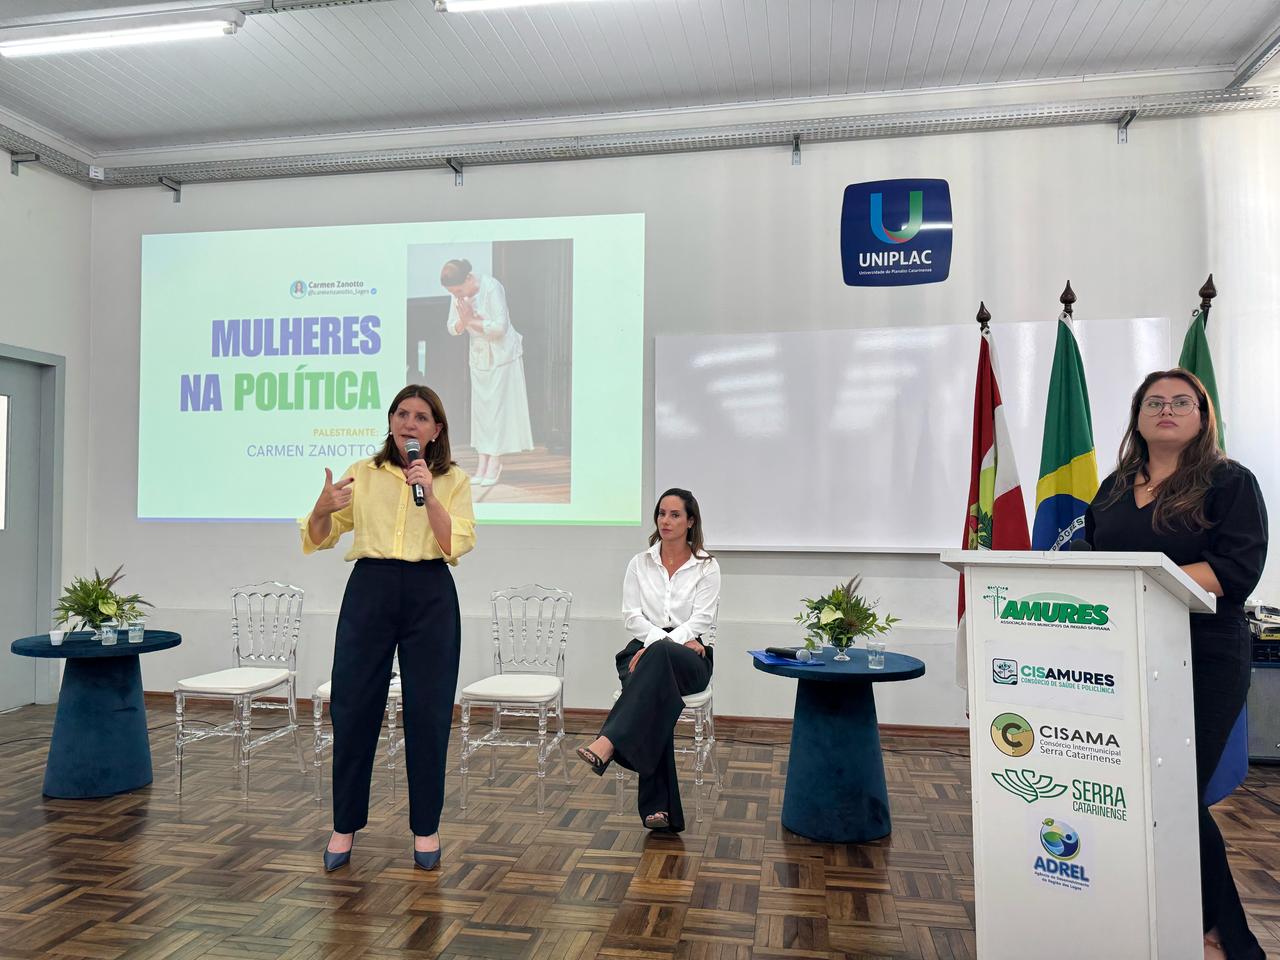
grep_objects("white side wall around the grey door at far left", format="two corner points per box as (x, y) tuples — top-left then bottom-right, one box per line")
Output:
(0, 155), (92, 601)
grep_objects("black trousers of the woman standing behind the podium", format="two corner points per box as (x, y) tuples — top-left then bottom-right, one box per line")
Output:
(1192, 617), (1266, 960)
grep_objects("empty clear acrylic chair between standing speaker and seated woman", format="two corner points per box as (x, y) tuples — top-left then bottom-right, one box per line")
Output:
(458, 584), (573, 813)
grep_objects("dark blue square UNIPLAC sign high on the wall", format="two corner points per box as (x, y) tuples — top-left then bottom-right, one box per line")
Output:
(840, 179), (951, 287)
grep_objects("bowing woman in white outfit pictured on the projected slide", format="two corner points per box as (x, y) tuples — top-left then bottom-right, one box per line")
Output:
(440, 260), (534, 486)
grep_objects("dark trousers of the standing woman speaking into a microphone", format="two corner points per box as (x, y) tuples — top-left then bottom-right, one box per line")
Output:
(329, 559), (462, 836)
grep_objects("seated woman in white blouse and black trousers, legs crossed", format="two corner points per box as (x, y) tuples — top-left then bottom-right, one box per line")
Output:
(577, 489), (719, 831)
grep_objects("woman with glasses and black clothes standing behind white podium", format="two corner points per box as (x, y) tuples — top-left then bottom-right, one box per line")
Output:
(1084, 367), (1267, 960)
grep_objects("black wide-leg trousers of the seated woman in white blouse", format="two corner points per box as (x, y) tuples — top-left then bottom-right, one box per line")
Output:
(600, 640), (713, 831)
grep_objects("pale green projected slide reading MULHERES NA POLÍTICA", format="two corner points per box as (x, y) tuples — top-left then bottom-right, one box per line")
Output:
(138, 214), (644, 524)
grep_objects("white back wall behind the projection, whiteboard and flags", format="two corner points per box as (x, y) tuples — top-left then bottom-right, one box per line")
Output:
(87, 113), (1280, 724)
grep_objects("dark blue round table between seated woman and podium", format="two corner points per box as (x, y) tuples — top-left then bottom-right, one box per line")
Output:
(754, 646), (924, 844)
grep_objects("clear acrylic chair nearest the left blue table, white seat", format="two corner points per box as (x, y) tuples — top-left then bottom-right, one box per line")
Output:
(173, 581), (307, 799)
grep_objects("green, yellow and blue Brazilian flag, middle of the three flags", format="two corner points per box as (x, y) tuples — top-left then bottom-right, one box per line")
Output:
(1032, 312), (1098, 550)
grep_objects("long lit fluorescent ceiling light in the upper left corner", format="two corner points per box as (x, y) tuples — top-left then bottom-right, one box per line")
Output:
(0, 8), (244, 58)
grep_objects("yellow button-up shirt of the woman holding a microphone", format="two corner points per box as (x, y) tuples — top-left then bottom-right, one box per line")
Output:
(298, 457), (476, 564)
